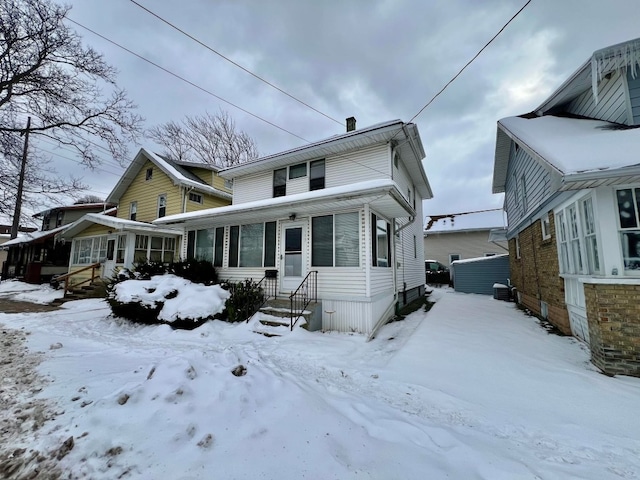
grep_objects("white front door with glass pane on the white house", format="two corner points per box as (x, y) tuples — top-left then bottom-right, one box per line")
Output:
(280, 224), (306, 292)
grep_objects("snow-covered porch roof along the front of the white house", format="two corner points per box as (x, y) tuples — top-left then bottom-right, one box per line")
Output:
(153, 179), (415, 228)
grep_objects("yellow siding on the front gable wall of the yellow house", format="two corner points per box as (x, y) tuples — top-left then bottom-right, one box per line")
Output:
(118, 161), (182, 222)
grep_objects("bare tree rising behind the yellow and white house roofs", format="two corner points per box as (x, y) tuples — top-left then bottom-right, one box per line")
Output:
(147, 110), (258, 167)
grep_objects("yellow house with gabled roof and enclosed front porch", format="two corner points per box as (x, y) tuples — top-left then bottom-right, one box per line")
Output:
(61, 148), (232, 285)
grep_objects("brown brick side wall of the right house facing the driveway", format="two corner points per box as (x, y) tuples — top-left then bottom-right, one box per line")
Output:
(509, 212), (571, 335)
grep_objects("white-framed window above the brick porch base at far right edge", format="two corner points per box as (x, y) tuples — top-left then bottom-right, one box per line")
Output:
(616, 188), (640, 274)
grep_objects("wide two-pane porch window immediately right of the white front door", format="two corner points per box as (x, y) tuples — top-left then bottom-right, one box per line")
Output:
(311, 212), (360, 267)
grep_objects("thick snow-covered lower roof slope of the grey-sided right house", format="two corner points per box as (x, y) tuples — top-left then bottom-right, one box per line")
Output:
(498, 115), (640, 182)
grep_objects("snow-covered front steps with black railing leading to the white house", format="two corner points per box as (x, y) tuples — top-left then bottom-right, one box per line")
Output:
(252, 299), (320, 337)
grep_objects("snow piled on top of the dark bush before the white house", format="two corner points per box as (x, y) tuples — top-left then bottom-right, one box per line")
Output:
(112, 275), (230, 323)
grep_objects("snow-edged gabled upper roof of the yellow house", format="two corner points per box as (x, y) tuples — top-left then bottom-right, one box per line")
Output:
(107, 148), (232, 203)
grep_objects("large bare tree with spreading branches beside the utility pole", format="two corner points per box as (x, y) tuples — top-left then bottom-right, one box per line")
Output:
(0, 0), (142, 231)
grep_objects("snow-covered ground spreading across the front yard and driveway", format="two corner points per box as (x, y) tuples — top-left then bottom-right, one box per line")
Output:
(0, 280), (640, 480)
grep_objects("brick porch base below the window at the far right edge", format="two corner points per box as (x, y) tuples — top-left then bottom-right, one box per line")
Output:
(584, 284), (640, 377)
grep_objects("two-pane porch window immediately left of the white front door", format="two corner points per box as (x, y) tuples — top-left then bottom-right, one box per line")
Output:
(229, 222), (276, 267)
